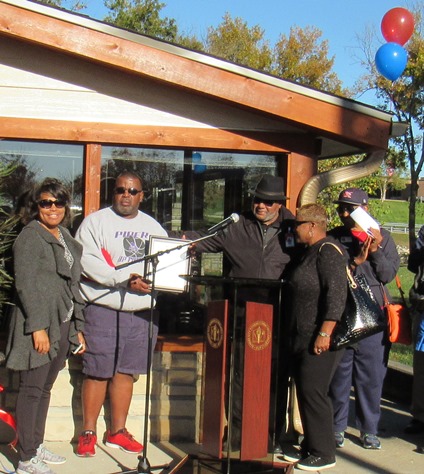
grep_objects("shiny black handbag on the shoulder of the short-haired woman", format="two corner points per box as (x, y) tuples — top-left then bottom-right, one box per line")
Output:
(323, 244), (387, 351)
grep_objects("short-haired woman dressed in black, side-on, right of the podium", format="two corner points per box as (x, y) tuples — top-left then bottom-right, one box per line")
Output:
(283, 204), (347, 471)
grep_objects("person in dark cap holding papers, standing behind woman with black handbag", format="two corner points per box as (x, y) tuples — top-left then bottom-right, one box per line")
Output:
(329, 188), (399, 449)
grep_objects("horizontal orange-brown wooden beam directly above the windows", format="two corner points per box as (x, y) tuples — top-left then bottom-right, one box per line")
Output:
(0, 117), (316, 156)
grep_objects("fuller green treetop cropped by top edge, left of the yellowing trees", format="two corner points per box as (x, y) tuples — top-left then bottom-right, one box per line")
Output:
(104, 0), (177, 42)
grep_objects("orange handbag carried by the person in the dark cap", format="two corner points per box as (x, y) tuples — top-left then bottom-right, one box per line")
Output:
(381, 275), (412, 346)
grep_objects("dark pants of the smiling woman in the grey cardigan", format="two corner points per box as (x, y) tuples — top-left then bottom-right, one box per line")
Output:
(16, 322), (69, 461)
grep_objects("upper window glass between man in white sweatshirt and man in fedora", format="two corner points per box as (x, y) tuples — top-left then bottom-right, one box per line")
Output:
(100, 146), (276, 230)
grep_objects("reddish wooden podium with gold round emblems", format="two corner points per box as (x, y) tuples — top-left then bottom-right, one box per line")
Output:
(186, 277), (291, 473)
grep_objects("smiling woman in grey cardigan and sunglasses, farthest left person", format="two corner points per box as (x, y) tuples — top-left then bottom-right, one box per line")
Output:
(6, 178), (85, 474)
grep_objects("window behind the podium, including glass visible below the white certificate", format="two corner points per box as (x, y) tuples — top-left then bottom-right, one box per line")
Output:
(100, 146), (277, 334)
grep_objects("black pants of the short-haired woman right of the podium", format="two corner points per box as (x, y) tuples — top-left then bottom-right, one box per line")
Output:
(293, 349), (344, 458)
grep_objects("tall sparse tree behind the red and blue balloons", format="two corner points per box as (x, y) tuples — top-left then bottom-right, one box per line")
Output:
(356, 0), (424, 246)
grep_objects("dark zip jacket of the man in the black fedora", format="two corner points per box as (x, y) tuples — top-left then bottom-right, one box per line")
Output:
(196, 207), (295, 280)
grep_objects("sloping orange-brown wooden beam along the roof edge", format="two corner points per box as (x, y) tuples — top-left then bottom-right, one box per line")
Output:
(0, 3), (391, 150)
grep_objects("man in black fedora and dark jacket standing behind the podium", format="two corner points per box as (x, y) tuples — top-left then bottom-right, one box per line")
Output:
(186, 174), (295, 452)
